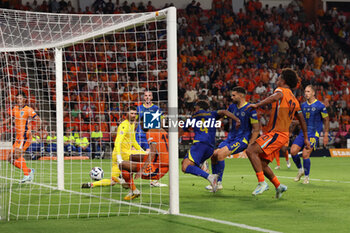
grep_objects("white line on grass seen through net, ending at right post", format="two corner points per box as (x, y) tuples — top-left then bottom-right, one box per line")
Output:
(0, 176), (169, 214)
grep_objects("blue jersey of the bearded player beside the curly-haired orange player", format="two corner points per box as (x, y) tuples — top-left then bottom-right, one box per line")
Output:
(227, 103), (258, 141)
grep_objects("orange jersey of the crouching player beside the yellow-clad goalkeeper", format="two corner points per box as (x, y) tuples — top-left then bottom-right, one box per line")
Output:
(146, 129), (169, 167)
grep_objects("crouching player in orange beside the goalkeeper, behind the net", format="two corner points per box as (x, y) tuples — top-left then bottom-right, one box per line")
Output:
(119, 123), (169, 200)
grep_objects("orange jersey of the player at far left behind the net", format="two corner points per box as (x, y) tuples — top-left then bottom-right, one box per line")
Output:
(10, 105), (37, 137)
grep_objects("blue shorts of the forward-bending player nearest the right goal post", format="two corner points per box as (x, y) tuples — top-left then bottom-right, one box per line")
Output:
(185, 142), (214, 167)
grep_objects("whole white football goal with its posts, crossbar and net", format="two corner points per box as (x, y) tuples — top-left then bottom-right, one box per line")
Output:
(0, 7), (179, 220)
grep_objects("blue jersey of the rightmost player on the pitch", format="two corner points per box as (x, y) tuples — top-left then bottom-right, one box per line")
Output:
(301, 100), (328, 137)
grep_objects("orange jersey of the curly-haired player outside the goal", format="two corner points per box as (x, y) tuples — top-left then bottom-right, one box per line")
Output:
(267, 87), (301, 136)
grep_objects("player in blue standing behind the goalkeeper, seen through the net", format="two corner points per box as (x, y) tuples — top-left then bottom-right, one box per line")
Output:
(136, 91), (161, 150)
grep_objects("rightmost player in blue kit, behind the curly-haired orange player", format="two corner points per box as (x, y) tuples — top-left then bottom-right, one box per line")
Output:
(290, 85), (329, 184)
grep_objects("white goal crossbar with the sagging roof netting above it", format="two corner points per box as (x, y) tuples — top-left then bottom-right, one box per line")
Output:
(0, 9), (167, 52)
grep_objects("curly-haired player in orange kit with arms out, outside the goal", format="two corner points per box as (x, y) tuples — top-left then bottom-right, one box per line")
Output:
(246, 69), (310, 198)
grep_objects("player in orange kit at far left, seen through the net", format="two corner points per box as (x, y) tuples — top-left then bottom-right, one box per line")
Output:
(0, 92), (41, 183)
